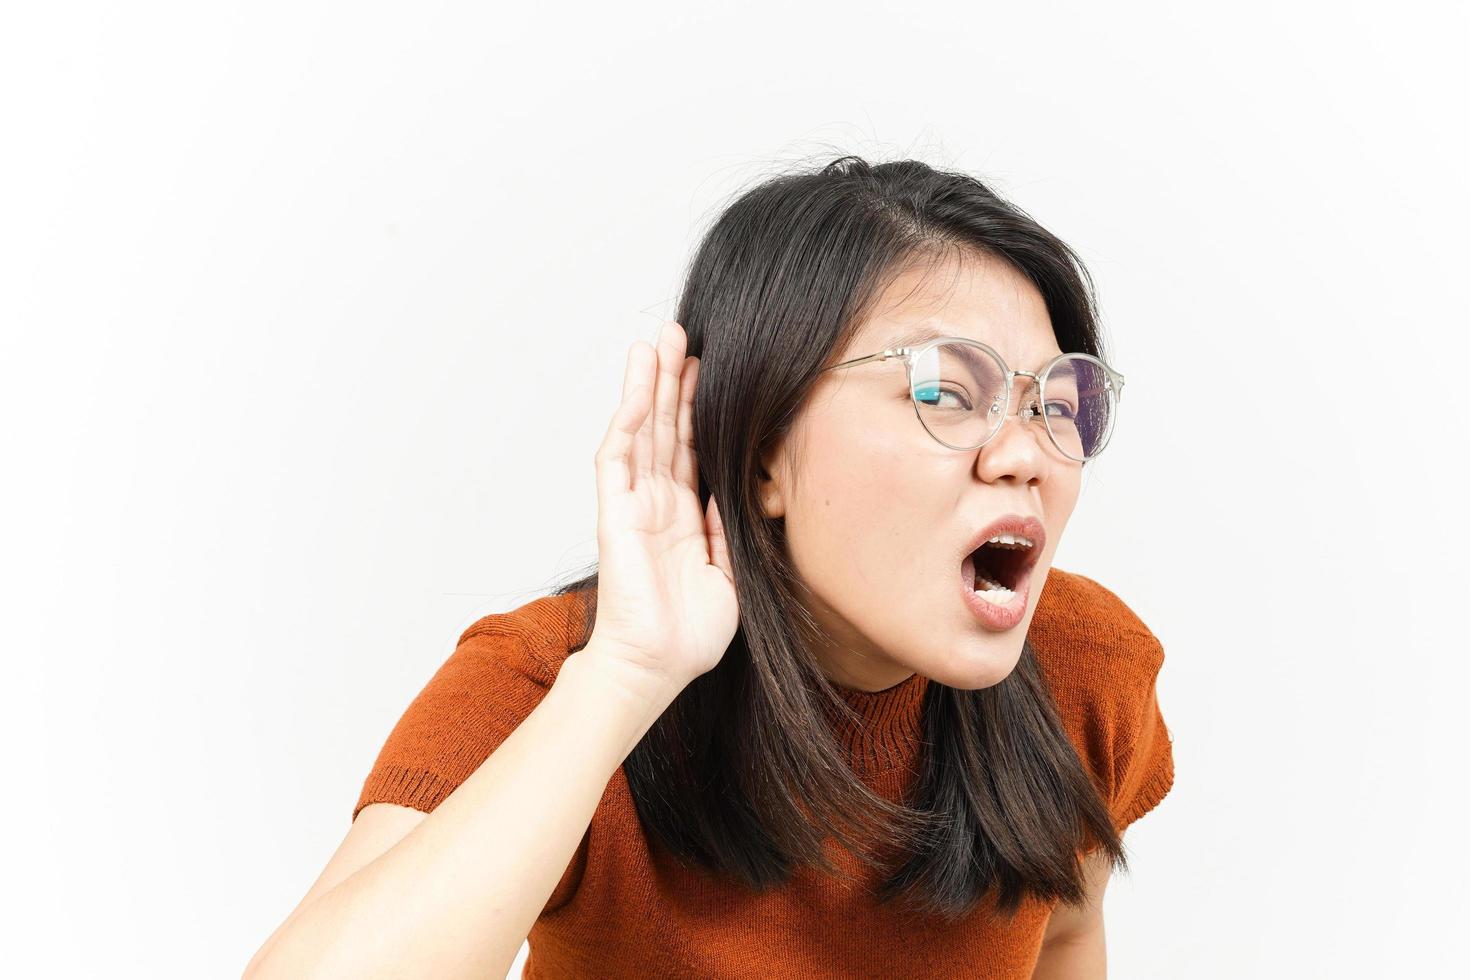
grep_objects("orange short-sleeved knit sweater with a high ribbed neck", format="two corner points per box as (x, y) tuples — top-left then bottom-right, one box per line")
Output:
(353, 567), (1173, 980)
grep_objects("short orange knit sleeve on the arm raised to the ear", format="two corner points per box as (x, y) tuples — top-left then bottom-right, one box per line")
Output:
(351, 616), (591, 911)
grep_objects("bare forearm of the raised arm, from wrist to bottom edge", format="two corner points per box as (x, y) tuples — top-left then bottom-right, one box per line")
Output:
(248, 646), (678, 980)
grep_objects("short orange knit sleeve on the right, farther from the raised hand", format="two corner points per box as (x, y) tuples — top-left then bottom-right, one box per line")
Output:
(1028, 569), (1175, 833)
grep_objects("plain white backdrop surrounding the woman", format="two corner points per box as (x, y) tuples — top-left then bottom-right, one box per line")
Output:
(0, 0), (1470, 979)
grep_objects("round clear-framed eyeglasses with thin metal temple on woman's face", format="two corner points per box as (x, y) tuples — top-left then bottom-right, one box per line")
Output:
(825, 336), (1123, 463)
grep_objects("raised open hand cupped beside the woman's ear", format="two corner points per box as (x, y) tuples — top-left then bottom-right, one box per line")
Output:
(588, 322), (739, 689)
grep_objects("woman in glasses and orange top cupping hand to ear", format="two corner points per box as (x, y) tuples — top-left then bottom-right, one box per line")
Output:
(248, 157), (1173, 979)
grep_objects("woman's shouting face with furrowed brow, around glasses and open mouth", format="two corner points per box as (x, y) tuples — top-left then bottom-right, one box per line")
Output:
(761, 254), (1082, 691)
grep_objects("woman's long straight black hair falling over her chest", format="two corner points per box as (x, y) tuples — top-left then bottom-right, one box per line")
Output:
(553, 156), (1126, 921)
